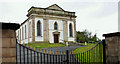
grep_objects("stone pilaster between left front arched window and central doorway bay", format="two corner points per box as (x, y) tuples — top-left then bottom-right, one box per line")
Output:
(43, 18), (49, 42)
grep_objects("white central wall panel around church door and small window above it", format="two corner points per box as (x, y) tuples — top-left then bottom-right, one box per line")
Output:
(49, 20), (63, 43)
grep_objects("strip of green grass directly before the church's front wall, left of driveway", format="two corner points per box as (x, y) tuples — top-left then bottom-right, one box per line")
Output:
(25, 43), (65, 49)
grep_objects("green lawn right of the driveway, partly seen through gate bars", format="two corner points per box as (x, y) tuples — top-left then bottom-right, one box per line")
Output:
(73, 43), (103, 64)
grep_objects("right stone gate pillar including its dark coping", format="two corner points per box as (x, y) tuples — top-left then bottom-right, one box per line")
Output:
(103, 32), (120, 64)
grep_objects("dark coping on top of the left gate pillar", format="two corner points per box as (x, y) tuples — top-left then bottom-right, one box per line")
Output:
(0, 22), (20, 30)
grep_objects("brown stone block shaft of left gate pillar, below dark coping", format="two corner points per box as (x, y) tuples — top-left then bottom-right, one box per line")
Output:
(2, 29), (16, 62)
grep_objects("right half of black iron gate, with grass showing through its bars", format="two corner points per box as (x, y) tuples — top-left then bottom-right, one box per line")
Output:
(70, 42), (103, 64)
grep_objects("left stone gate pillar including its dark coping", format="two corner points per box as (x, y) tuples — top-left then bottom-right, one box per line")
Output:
(0, 23), (20, 64)
